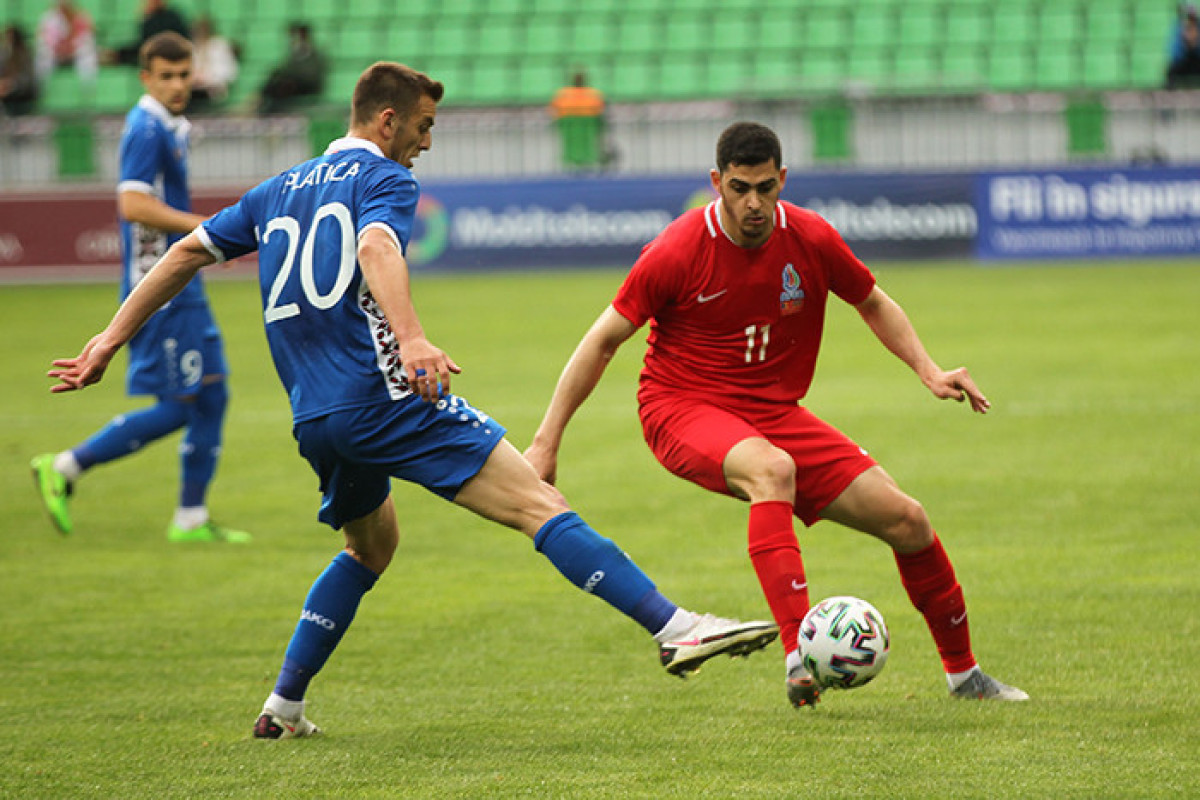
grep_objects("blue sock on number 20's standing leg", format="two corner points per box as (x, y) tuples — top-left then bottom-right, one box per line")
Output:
(275, 553), (379, 700)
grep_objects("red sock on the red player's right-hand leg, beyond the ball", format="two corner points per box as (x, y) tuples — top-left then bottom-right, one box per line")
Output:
(895, 534), (976, 672)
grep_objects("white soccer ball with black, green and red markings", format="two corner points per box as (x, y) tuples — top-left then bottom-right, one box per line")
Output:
(799, 597), (892, 688)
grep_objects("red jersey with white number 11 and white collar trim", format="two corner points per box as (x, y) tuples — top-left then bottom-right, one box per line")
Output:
(612, 200), (875, 404)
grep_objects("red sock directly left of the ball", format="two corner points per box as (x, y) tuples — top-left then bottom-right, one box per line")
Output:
(750, 500), (809, 652)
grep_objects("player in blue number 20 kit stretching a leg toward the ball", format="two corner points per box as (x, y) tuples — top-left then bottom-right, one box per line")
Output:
(49, 62), (779, 739)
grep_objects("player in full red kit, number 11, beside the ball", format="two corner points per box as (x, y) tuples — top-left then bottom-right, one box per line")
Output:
(526, 122), (1028, 708)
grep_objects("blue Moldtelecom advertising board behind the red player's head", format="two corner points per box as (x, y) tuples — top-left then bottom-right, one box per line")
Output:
(409, 173), (977, 270)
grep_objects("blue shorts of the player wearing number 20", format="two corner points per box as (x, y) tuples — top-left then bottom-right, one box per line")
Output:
(300, 395), (508, 530)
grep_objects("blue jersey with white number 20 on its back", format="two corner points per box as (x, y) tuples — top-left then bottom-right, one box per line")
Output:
(198, 138), (420, 422)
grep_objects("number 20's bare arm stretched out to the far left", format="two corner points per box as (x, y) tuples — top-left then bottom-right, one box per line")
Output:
(47, 233), (216, 392)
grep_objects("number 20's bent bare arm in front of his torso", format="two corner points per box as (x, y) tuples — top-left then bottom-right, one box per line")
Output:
(358, 228), (462, 403)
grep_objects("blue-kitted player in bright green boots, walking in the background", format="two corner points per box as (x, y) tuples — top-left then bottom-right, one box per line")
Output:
(32, 32), (250, 542)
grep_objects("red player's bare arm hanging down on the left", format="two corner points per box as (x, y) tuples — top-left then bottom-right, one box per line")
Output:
(524, 306), (637, 483)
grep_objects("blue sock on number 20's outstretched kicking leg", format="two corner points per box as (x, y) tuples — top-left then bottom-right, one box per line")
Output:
(533, 511), (678, 634)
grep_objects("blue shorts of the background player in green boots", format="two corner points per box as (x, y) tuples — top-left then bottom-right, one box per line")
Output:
(125, 306), (229, 397)
